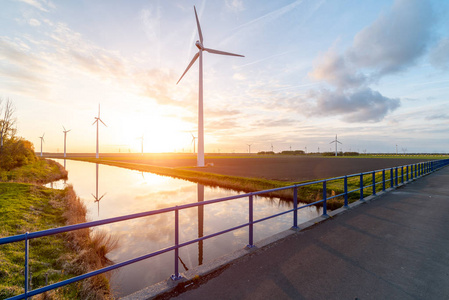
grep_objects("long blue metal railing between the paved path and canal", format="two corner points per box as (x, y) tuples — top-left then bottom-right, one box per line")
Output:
(0, 159), (449, 299)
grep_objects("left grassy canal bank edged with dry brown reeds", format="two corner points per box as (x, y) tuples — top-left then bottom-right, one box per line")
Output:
(0, 160), (117, 299)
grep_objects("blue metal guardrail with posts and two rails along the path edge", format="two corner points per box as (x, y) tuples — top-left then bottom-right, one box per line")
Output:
(0, 159), (449, 299)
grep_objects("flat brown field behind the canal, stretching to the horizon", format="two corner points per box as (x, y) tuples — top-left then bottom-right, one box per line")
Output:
(44, 153), (434, 182)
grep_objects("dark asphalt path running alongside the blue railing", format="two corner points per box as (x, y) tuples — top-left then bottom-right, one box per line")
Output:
(169, 168), (449, 300)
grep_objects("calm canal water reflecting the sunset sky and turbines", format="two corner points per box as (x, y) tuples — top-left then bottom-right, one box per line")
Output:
(47, 160), (321, 297)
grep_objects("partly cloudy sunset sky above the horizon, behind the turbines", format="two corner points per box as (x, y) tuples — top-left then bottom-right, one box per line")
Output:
(0, 0), (449, 153)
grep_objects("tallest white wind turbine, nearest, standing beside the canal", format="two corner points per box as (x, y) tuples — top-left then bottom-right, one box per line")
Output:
(176, 6), (244, 167)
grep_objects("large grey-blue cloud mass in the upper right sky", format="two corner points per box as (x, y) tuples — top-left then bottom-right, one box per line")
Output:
(309, 0), (434, 122)
